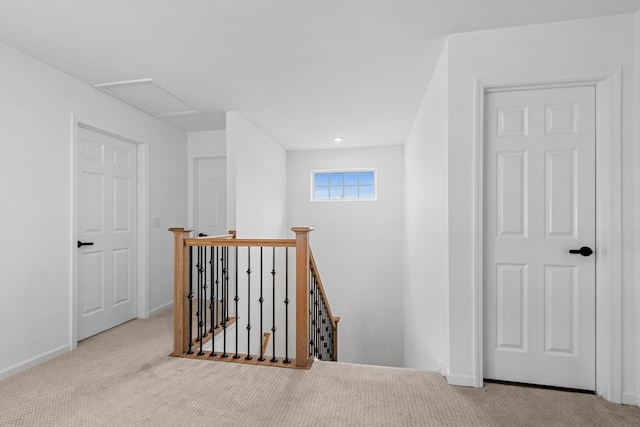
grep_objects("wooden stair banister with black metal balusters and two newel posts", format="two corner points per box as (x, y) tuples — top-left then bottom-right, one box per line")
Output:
(169, 227), (340, 369)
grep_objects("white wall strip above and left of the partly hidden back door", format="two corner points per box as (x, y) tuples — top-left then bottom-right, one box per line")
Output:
(187, 130), (227, 228)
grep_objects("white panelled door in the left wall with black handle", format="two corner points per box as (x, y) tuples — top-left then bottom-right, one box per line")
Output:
(77, 127), (137, 340)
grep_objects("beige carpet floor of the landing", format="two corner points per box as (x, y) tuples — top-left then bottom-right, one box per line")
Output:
(0, 311), (640, 426)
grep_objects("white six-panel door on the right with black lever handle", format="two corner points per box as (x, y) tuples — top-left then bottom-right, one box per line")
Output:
(483, 86), (596, 390)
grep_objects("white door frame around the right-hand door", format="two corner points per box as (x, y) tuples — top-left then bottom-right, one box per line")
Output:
(472, 68), (622, 403)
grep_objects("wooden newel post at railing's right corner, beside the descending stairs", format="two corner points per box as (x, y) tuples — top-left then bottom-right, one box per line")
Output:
(291, 227), (313, 368)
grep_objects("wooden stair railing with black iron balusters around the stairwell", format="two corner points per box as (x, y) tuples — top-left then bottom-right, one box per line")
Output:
(169, 227), (339, 369)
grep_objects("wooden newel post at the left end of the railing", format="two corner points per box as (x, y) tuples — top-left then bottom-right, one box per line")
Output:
(169, 228), (191, 356)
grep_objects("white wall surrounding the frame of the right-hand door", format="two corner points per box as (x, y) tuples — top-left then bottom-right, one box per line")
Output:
(449, 15), (640, 399)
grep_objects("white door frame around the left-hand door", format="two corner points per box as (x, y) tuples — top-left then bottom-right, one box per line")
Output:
(69, 113), (149, 349)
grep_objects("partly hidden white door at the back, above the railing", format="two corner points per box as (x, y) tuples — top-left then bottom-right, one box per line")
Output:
(195, 157), (228, 236)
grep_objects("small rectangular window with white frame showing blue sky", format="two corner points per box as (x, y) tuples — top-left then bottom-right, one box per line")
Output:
(311, 169), (377, 201)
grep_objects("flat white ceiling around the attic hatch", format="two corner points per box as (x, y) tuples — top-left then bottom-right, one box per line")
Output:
(0, 0), (640, 150)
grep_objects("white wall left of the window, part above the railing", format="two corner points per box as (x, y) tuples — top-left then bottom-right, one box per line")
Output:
(227, 111), (286, 239)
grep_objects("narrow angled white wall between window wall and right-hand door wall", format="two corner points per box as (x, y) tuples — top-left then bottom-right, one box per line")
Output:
(404, 43), (449, 374)
